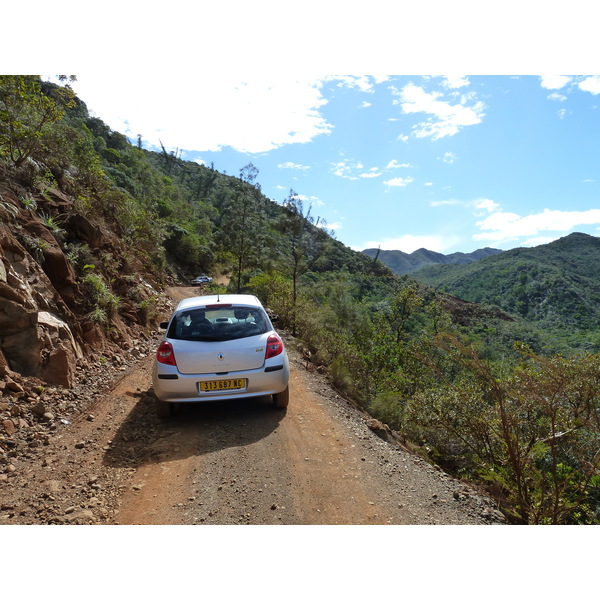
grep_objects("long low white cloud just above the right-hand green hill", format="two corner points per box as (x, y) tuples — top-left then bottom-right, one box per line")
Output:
(473, 208), (600, 242)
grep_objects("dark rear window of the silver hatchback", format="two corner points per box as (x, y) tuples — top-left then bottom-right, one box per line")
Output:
(167, 305), (271, 342)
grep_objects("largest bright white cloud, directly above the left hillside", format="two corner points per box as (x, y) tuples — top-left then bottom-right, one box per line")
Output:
(73, 70), (332, 153)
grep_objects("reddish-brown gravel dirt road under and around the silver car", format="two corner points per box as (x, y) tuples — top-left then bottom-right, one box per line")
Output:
(2, 288), (500, 525)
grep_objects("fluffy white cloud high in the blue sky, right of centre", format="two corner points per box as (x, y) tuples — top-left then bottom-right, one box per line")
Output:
(393, 83), (484, 140)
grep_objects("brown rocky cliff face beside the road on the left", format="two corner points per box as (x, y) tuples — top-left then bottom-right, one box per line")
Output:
(0, 164), (169, 396)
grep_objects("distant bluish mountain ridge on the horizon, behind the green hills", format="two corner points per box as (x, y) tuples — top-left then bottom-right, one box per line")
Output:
(363, 248), (502, 275)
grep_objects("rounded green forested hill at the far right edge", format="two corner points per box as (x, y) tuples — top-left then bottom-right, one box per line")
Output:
(414, 233), (600, 351)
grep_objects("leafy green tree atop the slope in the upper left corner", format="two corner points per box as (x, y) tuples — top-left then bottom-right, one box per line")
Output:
(0, 75), (75, 168)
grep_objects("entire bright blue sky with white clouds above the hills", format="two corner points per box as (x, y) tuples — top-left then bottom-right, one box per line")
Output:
(67, 73), (600, 254)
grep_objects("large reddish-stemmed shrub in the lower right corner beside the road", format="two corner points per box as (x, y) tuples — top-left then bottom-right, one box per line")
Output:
(405, 341), (600, 524)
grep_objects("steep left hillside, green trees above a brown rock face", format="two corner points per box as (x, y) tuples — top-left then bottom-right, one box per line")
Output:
(0, 76), (392, 387)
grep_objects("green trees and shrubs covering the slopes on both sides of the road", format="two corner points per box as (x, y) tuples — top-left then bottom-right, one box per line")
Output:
(0, 76), (600, 523)
